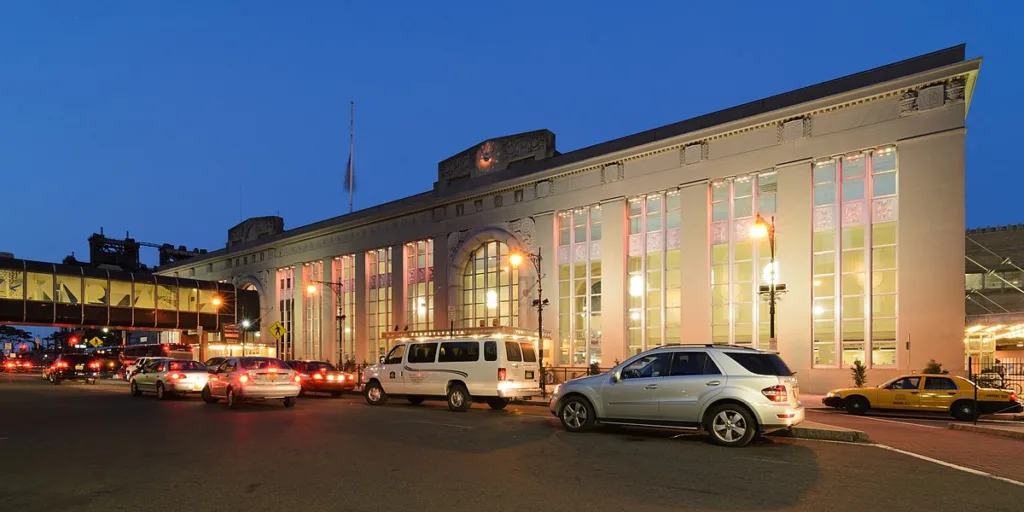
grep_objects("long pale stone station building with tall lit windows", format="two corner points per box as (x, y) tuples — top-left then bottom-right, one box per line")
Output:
(158, 45), (981, 392)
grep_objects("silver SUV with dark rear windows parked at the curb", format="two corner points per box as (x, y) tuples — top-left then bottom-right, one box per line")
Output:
(549, 345), (804, 446)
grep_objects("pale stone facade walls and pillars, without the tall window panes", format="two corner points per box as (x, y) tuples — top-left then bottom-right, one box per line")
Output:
(160, 47), (980, 392)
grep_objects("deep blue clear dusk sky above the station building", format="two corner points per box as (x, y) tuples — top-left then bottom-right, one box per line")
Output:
(0, 0), (1024, 264)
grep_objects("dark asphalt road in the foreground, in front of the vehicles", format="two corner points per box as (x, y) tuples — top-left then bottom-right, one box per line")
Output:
(0, 379), (1024, 512)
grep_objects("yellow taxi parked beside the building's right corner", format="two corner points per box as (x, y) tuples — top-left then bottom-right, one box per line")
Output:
(821, 374), (1022, 421)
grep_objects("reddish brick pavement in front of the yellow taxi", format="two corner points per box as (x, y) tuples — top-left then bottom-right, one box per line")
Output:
(807, 410), (1024, 482)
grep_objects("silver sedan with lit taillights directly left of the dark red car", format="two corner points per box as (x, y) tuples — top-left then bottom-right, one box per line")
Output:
(203, 357), (302, 409)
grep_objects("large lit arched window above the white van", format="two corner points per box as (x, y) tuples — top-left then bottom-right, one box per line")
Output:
(462, 242), (519, 327)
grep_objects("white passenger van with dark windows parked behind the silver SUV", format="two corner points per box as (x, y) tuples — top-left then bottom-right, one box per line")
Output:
(362, 337), (541, 412)
